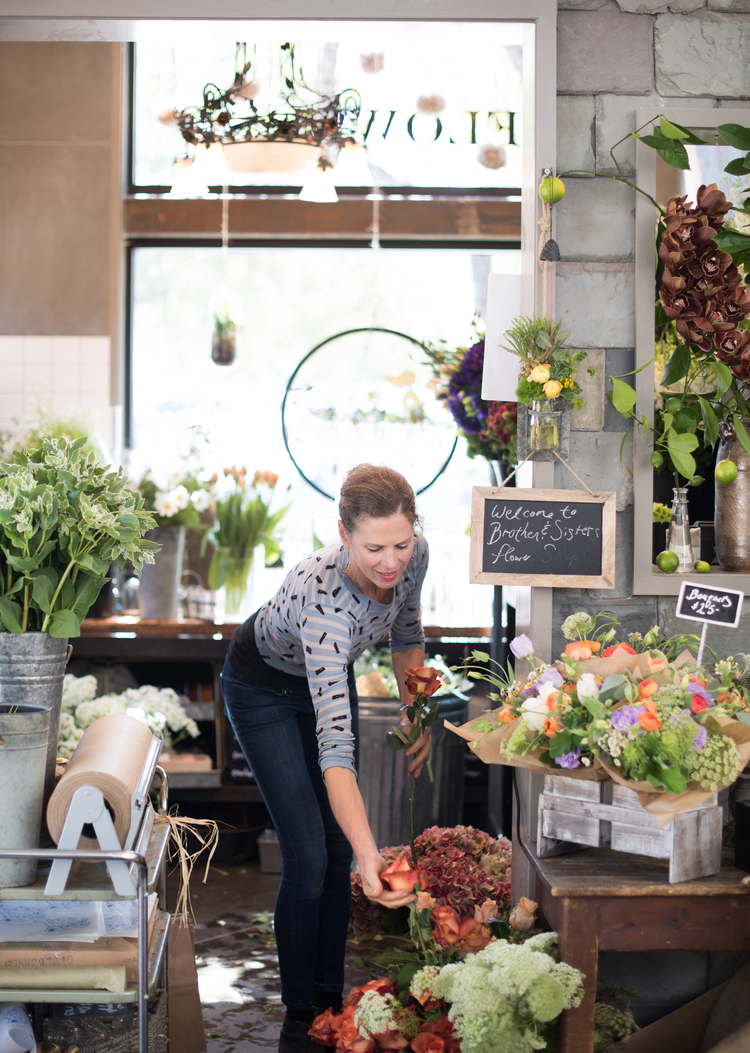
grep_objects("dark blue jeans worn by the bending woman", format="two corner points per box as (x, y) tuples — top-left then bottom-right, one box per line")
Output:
(221, 660), (358, 1011)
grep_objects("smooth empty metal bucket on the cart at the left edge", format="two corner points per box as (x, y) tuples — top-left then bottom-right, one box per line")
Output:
(0, 702), (51, 888)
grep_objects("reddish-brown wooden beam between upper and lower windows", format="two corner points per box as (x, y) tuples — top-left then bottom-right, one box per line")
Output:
(125, 197), (520, 242)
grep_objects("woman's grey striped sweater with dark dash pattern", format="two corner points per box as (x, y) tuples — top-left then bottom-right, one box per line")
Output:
(255, 536), (429, 772)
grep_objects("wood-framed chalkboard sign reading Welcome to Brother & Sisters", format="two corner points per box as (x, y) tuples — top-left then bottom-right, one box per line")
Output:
(470, 486), (617, 589)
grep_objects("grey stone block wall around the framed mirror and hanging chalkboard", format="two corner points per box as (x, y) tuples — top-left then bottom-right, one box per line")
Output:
(552, 0), (750, 654)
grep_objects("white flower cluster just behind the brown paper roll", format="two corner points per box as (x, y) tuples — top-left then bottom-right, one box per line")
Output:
(57, 676), (199, 757)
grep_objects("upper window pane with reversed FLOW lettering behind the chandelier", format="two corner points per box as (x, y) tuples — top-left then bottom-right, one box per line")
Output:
(134, 22), (522, 187)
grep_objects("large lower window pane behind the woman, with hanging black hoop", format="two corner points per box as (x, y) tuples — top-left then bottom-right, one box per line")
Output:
(132, 247), (520, 625)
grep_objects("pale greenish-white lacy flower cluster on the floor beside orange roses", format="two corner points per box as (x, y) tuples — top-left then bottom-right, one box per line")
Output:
(413, 933), (583, 1053)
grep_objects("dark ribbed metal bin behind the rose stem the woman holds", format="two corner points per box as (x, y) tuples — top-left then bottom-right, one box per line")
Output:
(358, 695), (469, 848)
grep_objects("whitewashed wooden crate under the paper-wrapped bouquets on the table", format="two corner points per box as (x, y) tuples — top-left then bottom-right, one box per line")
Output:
(536, 775), (723, 885)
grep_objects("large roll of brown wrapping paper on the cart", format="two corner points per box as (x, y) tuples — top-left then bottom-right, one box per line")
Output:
(46, 713), (153, 849)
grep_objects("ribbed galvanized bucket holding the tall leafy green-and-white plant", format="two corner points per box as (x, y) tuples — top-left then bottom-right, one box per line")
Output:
(0, 633), (68, 821)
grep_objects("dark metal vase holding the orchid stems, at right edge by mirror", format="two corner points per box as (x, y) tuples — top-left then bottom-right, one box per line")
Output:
(714, 417), (750, 572)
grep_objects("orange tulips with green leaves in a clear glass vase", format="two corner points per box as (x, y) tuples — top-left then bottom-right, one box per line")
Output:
(206, 464), (289, 620)
